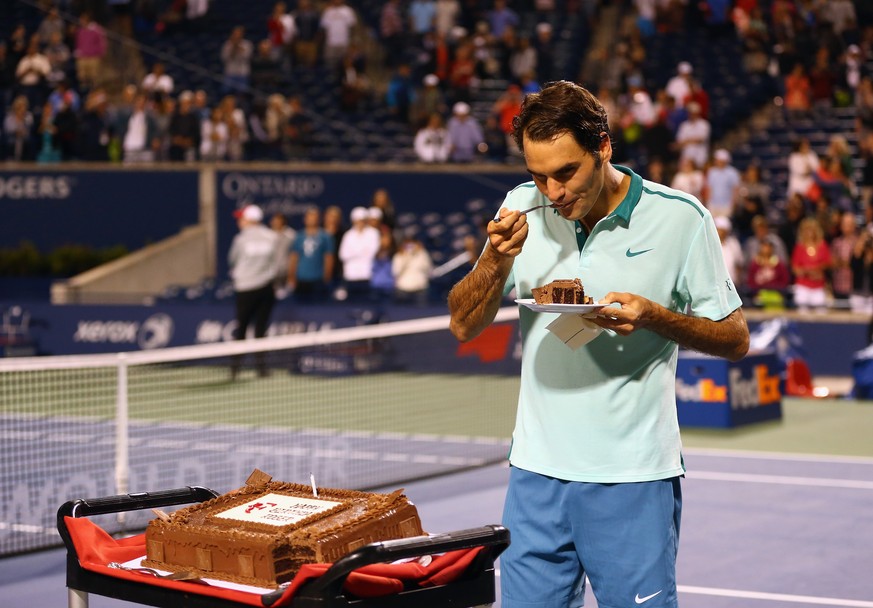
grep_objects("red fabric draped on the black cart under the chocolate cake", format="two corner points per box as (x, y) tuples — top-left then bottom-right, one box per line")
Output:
(64, 517), (483, 607)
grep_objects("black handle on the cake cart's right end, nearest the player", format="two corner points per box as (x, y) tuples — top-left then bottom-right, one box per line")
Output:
(261, 524), (509, 606)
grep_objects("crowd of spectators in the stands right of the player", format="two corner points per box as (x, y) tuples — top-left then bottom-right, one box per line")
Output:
(600, 0), (873, 314)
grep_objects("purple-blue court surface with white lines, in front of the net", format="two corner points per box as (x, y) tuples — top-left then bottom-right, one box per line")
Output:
(0, 448), (873, 608)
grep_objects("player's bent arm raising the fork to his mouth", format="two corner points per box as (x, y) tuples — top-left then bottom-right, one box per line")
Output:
(448, 209), (528, 342)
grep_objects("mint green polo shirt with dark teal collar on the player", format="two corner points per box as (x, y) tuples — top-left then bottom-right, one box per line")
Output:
(504, 166), (742, 483)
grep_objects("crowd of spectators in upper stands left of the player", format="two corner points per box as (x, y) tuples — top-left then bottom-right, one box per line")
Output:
(0, 0), (580, 162)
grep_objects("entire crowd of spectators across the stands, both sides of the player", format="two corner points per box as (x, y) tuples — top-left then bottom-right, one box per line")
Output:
(0, 0), (873, 312)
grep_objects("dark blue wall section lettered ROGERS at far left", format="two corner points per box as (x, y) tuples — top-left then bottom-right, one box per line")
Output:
(0, 170), (199, 251)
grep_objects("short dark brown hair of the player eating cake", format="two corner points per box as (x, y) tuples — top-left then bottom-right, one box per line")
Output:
(512, 80), (609, 157)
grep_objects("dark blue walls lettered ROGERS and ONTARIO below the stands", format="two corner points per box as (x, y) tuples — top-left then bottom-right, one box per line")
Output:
(0, 167), (529, 279)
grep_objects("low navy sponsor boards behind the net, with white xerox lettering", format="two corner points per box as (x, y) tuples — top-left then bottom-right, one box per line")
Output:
(0, 300), (520, 376)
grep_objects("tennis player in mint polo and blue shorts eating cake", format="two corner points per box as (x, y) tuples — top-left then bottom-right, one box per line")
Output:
(449, 82), (749, 608)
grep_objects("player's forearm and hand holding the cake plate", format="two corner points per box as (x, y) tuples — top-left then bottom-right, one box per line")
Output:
(592, 292), (749, 361)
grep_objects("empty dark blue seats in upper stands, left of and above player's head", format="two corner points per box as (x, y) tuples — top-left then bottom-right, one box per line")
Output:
(129, 0), (589, 163)
